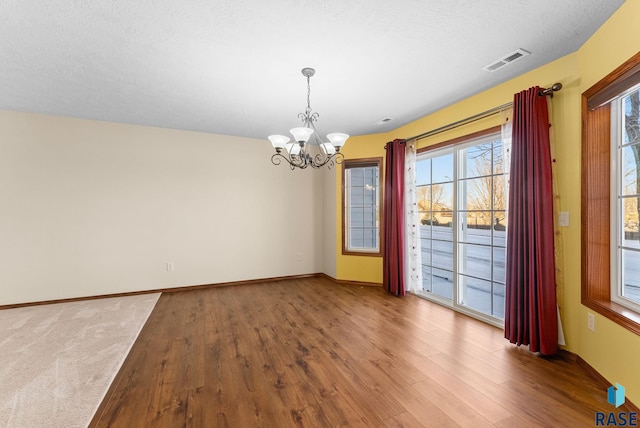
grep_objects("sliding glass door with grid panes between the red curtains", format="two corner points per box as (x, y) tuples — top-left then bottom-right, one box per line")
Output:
(416, 128), (510, 324)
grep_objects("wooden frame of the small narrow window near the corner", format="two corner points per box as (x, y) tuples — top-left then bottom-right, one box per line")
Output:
(342, 157), (384, 257)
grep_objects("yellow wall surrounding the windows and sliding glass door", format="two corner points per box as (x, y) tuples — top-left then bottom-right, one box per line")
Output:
(337, 0), (640, 403)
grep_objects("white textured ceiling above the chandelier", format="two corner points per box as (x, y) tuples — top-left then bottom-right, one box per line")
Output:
(0, 0), (624, 138)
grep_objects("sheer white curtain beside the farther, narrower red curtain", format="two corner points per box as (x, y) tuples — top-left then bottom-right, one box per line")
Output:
(404, 140), (422, 293)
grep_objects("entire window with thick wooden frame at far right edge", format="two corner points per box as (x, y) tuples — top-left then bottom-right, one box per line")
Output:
(581, 49), (640, 334)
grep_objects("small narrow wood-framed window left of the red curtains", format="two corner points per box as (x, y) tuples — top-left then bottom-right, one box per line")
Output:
(342, 158), (382, 256)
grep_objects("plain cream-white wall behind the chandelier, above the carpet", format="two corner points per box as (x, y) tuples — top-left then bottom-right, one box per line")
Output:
(0, 111), (323, 305)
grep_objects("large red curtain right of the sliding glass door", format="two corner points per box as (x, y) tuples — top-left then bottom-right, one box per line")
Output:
(504, 87), (558, 355)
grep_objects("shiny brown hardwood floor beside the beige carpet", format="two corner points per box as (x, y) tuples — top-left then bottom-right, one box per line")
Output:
(90, 278), (629, 427)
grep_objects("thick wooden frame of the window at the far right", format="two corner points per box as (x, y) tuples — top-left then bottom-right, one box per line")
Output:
(581, 52), (640, 335)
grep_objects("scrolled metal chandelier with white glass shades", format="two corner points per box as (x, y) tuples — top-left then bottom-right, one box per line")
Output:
(268, 68), (349, 169)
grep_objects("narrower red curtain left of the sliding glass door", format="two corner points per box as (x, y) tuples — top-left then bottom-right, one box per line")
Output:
(382, 140), (405, 296)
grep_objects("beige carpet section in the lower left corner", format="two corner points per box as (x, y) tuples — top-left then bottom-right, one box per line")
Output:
(0, 294), (160, 428)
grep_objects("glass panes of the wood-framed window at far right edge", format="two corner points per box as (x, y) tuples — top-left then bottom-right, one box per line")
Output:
(611, 85), (640, 312)
